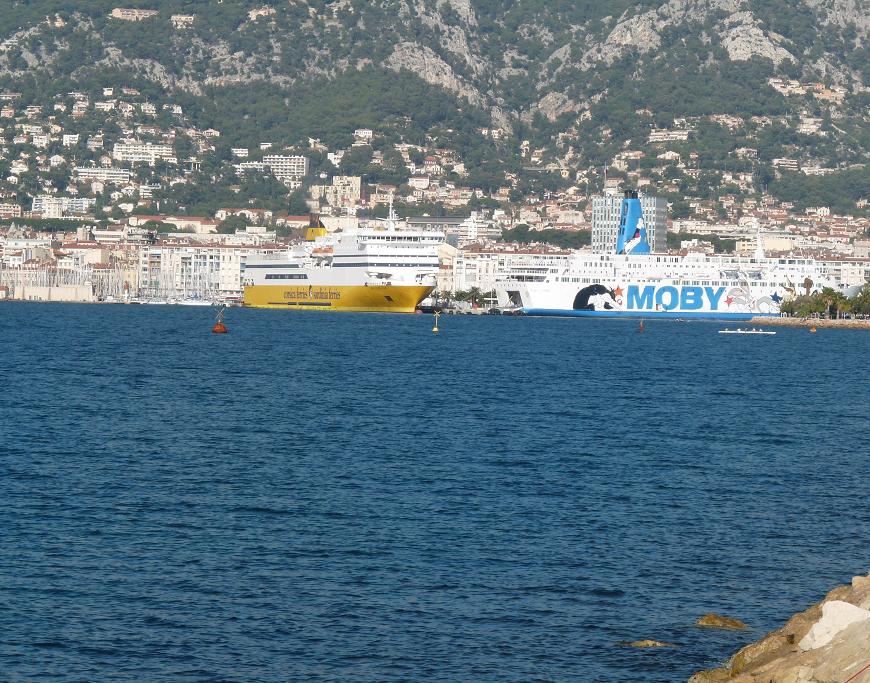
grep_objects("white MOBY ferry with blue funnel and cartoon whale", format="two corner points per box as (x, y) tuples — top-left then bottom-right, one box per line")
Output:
(496, 193), (841, 320)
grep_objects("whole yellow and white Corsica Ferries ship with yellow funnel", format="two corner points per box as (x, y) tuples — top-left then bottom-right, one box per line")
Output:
(242, 207), (444, 313)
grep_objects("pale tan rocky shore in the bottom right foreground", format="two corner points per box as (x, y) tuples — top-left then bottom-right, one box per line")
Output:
(689, 574), (870, 683)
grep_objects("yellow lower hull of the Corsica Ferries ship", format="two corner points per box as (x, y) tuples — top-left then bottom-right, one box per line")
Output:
(243, 285), (435, 313)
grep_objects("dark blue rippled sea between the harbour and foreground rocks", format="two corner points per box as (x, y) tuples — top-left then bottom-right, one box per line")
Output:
(0, 303), (870, 683)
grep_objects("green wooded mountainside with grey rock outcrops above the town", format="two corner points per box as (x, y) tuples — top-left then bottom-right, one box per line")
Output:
(0, 0), (870, 208)
